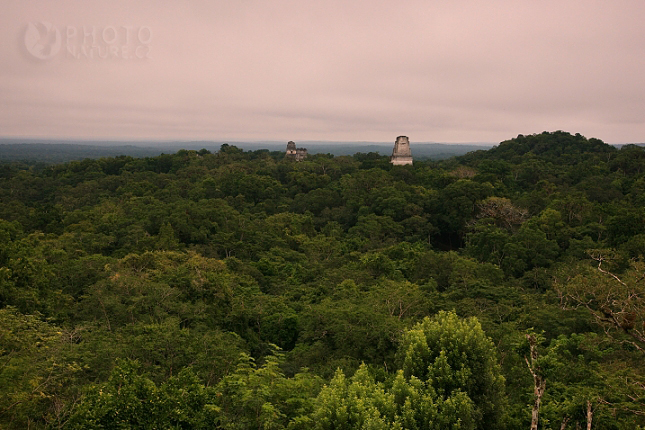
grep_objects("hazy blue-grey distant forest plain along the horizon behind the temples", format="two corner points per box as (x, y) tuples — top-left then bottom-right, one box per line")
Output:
(0, 138), (494, 163)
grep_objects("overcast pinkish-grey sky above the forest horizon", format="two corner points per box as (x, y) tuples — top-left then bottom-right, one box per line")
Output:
(0, 0), (645, 144)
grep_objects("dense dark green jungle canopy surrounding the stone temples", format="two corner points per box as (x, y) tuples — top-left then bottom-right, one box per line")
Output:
(0, 131), (645, 429)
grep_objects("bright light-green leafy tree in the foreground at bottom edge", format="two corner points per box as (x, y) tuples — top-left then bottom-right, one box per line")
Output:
(311, 312), (505, 430)
